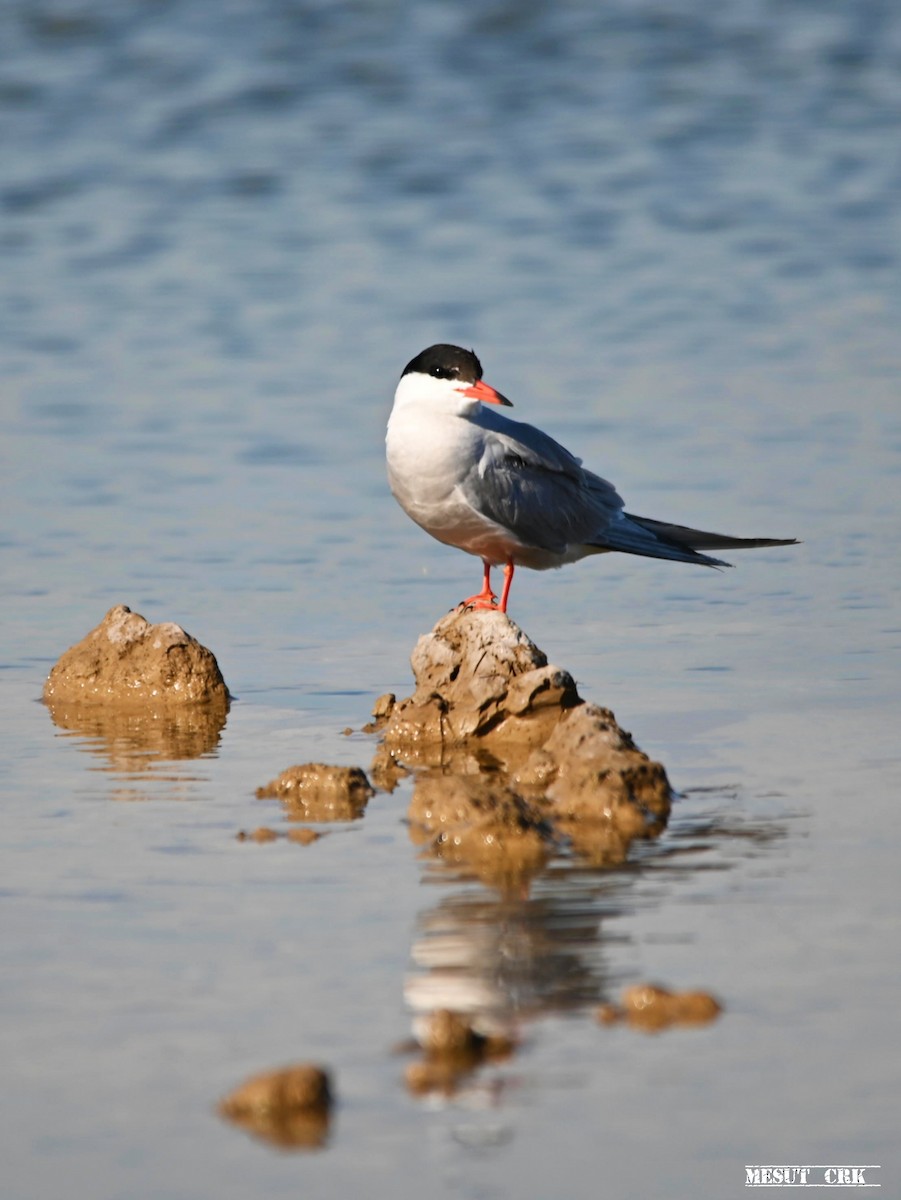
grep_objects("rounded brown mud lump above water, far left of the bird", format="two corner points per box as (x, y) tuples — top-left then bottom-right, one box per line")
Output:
(43, 605), (229, 720)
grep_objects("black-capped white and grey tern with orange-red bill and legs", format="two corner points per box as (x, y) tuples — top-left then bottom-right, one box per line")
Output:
(385, 343), (797, 613)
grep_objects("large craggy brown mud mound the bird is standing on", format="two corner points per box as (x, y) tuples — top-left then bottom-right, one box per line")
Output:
(372, 606), (671, 876)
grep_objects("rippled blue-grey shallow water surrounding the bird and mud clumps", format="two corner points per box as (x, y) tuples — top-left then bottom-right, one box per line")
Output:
(0, 0), (901, 1200)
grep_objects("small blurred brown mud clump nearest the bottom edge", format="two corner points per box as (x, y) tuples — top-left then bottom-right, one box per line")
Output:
(218, 1063), (332, 1150)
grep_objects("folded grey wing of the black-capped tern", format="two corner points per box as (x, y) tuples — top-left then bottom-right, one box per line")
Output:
(462, 410), (628, 554)
